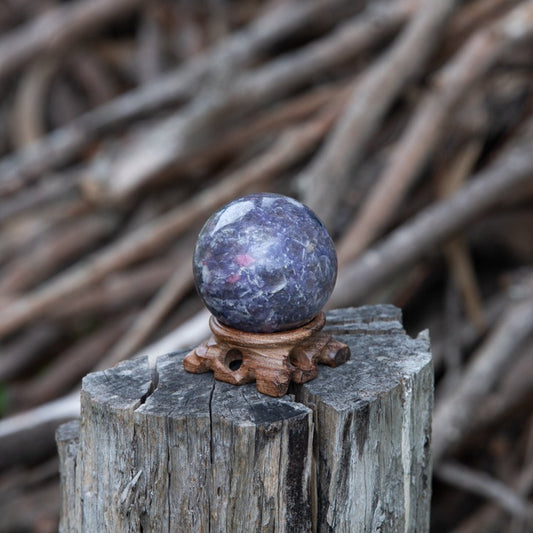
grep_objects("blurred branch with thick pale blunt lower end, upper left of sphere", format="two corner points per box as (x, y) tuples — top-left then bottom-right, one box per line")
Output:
(81, 0), (413, 201)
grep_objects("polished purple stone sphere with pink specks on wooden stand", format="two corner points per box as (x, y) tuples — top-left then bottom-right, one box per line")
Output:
(193, 193), (337, 333)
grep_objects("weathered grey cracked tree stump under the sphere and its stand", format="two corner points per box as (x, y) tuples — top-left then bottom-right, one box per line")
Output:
(58, 306), (433, 533)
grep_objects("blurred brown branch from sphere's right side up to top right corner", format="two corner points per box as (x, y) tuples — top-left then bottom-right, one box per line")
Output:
(339, 2), (533, 263)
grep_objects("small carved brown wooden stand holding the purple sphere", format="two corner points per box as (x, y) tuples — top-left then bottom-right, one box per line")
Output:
(183, 313), (350, 397)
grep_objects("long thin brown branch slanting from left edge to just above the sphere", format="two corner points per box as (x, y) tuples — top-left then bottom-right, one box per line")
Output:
(0, 109), (339, 337)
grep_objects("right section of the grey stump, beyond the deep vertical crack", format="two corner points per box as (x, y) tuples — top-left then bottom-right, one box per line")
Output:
(296, 306), (433, 533)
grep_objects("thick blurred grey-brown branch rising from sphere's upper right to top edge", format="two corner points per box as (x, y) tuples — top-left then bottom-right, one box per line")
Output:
(301, 0), (456, 227)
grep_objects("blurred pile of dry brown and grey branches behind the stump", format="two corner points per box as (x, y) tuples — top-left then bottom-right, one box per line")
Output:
(0, 0), (533, 533)
